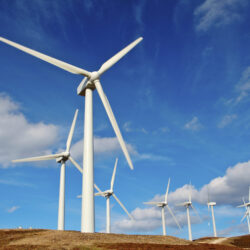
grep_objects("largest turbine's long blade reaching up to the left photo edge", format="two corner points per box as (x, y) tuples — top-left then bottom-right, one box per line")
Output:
(0, 37), (91, 77)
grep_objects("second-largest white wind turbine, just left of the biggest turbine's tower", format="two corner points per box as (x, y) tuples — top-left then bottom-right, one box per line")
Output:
(12, 109), (82, 230)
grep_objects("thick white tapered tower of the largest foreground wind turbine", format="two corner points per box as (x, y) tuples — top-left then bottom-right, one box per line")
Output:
(81, 88), (95, 233)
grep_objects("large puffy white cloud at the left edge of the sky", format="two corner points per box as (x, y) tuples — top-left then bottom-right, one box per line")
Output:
(0, 93), (58, 167)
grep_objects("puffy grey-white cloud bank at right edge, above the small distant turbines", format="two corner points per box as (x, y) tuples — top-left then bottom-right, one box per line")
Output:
(153, 161), (250, 205)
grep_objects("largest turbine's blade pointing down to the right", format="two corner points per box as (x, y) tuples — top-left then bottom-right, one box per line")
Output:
(95, 80), (134, 169)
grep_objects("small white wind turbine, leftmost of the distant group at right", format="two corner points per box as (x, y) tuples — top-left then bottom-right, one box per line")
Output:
(143, 178), (181, 235)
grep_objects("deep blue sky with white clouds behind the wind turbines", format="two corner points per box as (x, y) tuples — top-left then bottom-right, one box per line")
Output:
(0, 0), (250, 238)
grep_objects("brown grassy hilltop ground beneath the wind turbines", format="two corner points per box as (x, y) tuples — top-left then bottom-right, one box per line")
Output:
(0, 229), (250, 250)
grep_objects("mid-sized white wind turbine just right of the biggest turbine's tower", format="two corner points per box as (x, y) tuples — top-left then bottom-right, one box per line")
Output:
(95, 158), (133, 233)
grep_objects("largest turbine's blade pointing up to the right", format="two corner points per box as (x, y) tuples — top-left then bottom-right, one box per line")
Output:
(98, 37), (143, 75)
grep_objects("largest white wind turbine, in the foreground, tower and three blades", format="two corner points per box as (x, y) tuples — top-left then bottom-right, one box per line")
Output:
(0, 37), (143, 233)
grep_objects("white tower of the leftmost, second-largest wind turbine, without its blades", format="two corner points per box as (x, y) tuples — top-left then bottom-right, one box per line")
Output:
(57, 162), (65, 230)
